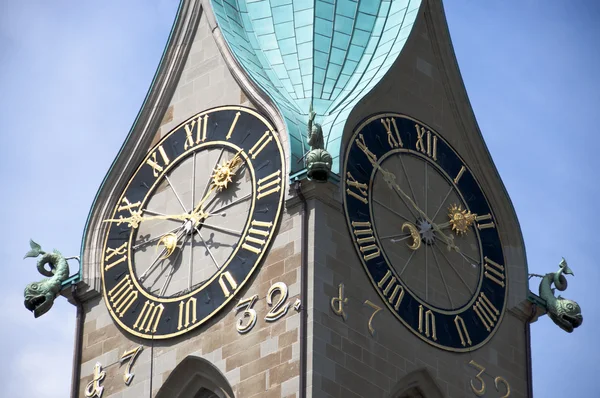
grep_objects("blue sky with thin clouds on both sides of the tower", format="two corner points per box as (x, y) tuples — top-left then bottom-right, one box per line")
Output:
(0, 0), (600, 398)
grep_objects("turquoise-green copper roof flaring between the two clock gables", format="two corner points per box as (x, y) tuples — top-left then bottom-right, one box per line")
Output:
(212, 0), (421, 173)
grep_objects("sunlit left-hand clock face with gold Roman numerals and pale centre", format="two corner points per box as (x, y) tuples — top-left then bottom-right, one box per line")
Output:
(102, 106), (284, 339)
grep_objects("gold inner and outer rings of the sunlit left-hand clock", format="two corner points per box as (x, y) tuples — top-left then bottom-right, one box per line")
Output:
(99, 105), (287, 340)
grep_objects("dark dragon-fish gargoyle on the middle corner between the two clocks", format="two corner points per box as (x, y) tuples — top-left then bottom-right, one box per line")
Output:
(306, 104), (333, 182)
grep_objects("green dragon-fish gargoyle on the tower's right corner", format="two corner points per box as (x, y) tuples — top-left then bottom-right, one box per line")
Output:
(532, 258), (583, 333)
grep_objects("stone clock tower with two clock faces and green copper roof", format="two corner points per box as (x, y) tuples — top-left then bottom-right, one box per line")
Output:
(59, 0), (531, 398)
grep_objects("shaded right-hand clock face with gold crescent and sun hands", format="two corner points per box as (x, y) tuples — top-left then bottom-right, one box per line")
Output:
(343, 113), (507, 351)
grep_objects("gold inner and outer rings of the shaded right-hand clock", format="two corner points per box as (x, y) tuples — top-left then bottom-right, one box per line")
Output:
(342, 112), (509, 352)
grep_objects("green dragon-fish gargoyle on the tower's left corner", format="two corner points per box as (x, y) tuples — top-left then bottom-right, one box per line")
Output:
(23, 240), (74, 318)
